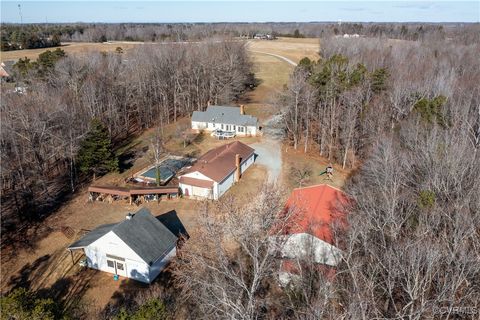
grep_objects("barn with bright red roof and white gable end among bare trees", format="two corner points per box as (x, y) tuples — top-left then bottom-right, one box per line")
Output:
(272, 184), (349, 285)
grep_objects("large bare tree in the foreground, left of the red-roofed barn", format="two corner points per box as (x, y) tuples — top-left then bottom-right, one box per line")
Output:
(175, 185), (289, 319)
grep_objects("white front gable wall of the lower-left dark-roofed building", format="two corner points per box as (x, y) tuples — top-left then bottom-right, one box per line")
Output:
(84, 231), (150, 283)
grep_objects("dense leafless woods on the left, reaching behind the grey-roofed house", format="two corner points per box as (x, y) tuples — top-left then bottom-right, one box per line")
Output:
(1, 43), (252, 238)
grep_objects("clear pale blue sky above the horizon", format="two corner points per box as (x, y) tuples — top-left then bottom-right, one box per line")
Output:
(1, 0), (480, 23)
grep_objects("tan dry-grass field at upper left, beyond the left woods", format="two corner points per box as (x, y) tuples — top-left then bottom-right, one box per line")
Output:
(0, 42), (142, 61)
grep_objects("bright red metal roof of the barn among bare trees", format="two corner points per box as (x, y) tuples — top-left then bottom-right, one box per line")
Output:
(285, 184), (349, 245)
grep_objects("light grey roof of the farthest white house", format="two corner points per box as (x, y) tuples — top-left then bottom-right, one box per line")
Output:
(192, 106), (258, 126)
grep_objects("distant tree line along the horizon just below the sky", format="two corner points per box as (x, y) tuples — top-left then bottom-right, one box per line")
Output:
(1, 22), (480, 51)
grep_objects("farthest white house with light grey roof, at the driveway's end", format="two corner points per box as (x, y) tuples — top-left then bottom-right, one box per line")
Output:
(192, 105), (259, 136)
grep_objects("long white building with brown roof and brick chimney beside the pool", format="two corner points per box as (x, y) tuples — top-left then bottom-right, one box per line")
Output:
(179, 141), (255, 200)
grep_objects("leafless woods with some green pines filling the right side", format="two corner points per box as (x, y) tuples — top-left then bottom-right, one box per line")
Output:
(279, 30), (480, 319)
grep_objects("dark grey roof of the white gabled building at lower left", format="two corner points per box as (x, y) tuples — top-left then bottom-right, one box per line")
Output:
(69, 208), (177, 265)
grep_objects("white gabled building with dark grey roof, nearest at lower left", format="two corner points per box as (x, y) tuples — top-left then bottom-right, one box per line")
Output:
(67, 208), (178, 283)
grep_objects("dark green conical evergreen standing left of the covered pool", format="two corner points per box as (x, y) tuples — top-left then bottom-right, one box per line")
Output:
(78, 119), (118, 179)
